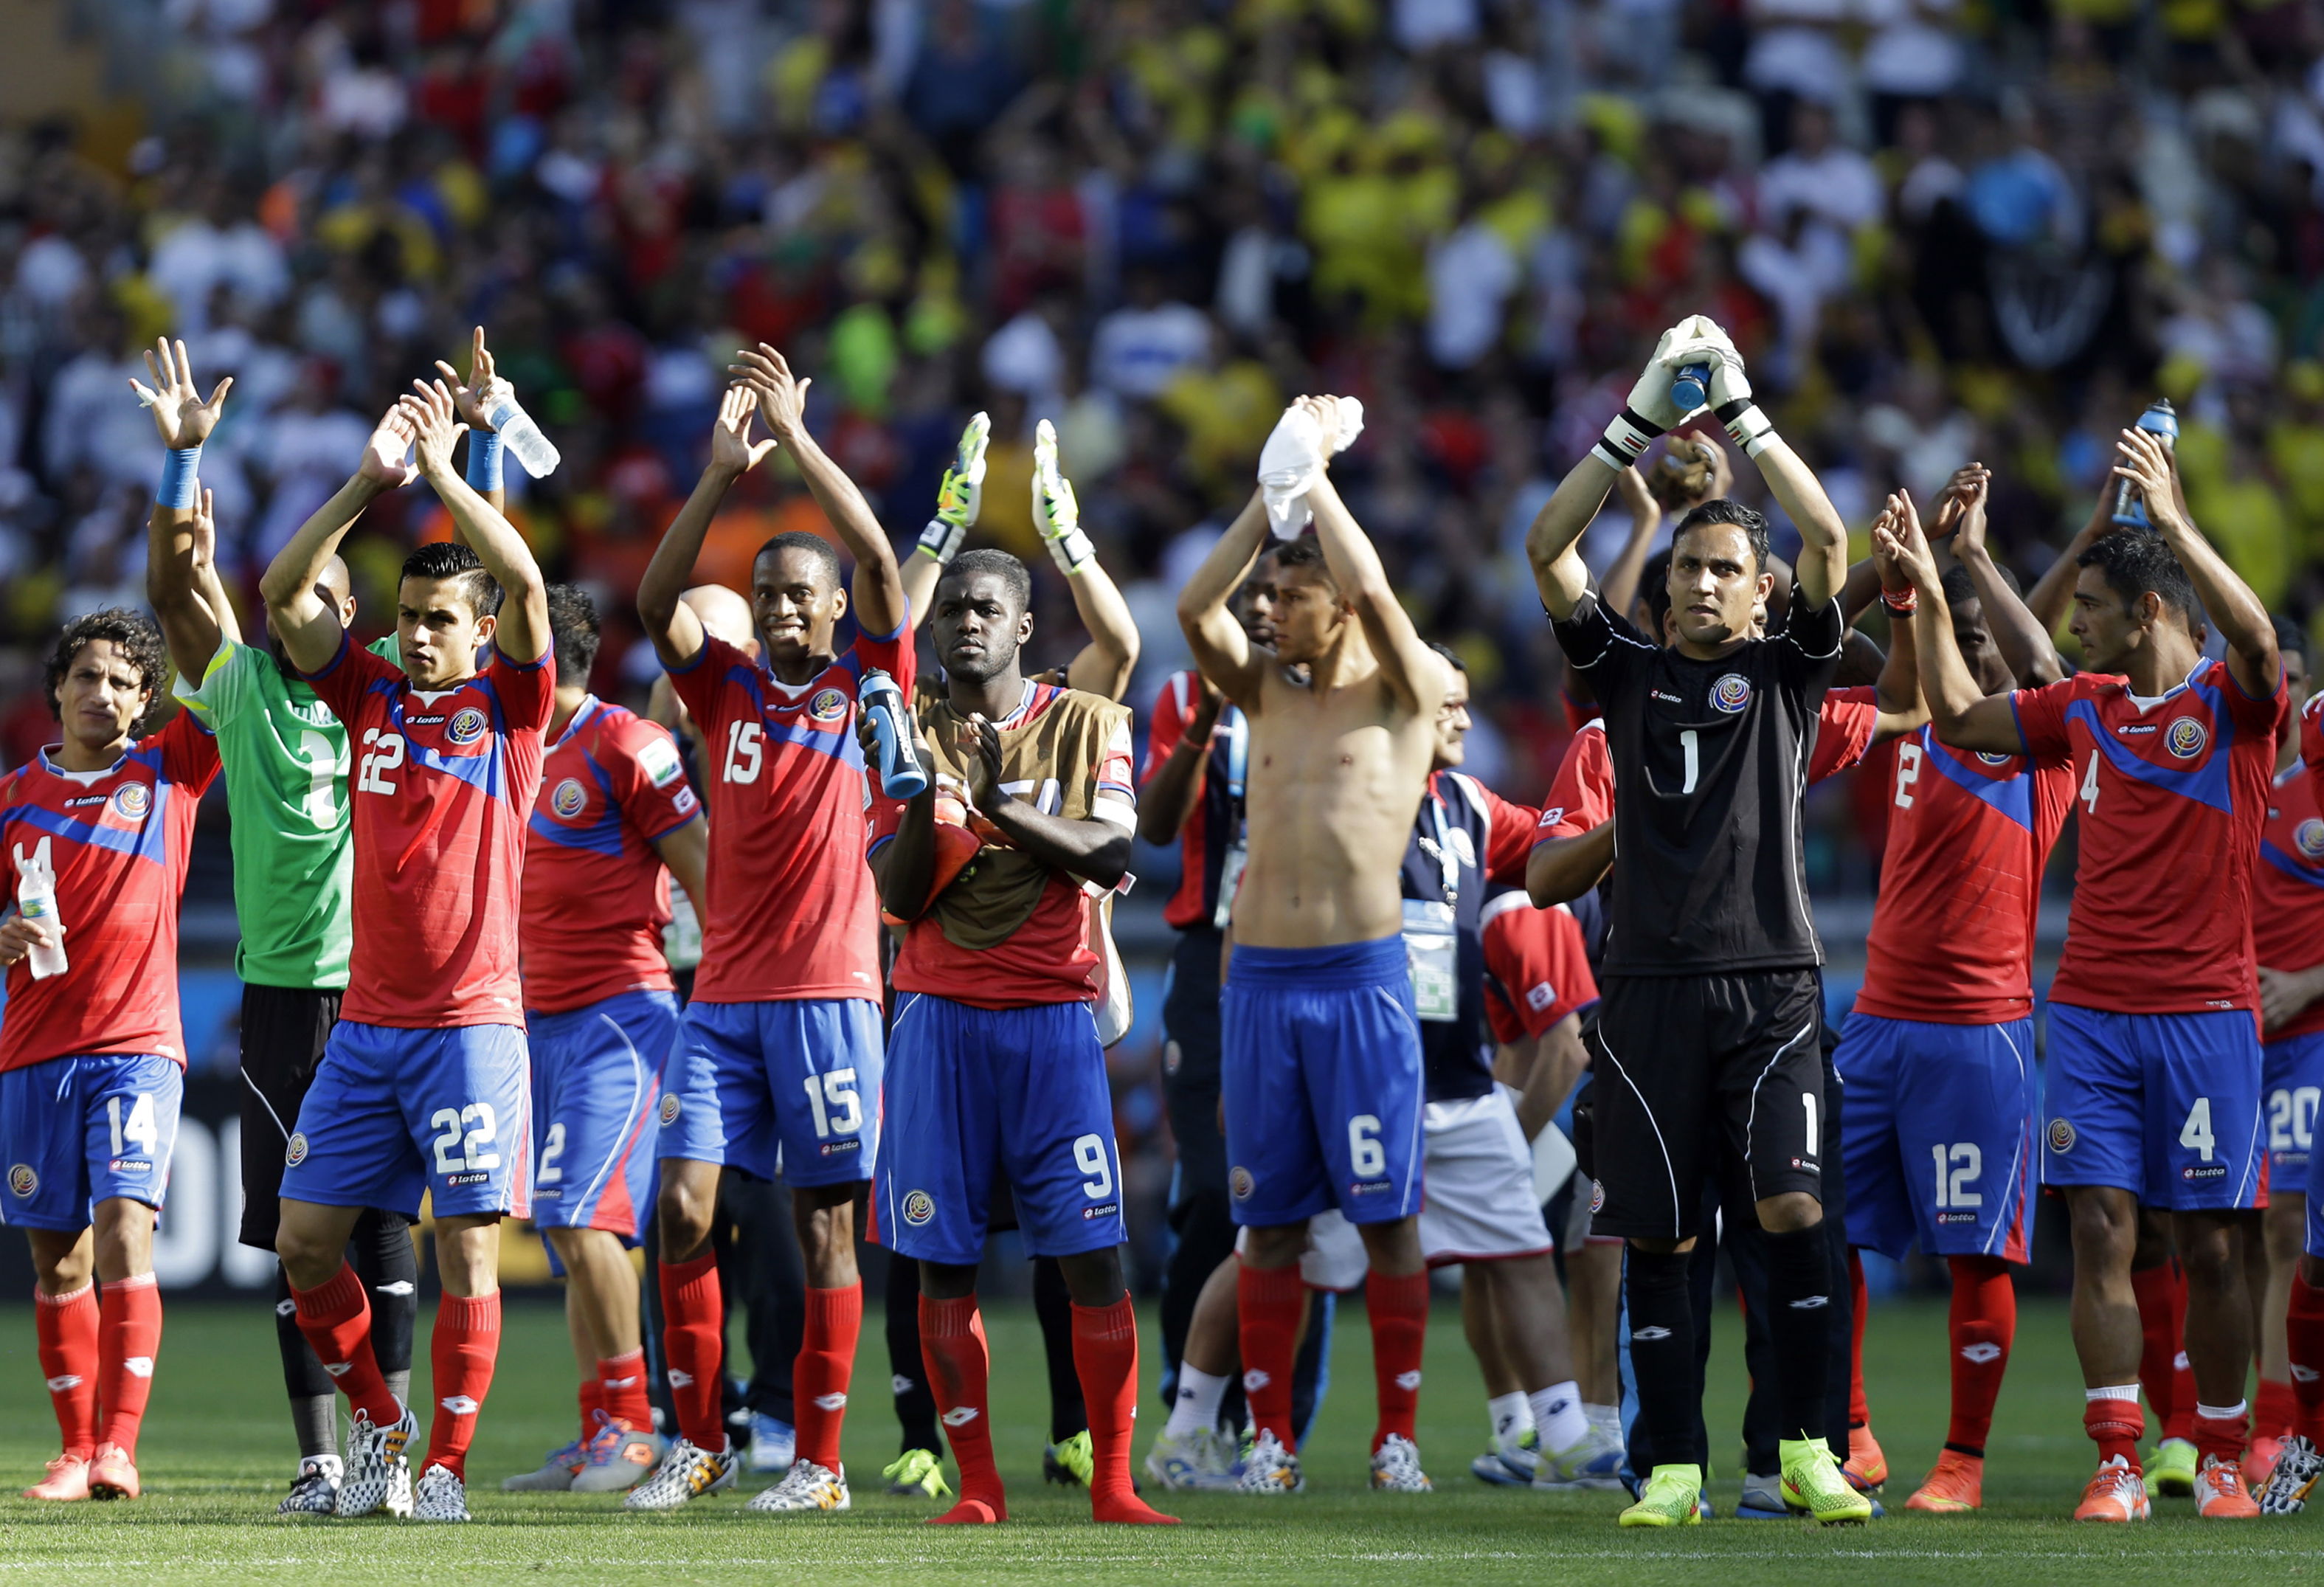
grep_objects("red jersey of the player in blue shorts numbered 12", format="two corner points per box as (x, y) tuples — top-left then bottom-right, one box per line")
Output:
(1857, 727), (2073, 1025)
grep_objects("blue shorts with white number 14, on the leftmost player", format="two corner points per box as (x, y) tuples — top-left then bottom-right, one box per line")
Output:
(0, 1053), (186, 1234)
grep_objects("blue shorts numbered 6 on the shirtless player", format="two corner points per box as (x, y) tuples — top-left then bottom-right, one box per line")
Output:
(1220, 936), (1425, 1229)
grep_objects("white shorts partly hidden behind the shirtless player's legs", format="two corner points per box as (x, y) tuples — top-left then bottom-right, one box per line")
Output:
(1237, 1088), (1557, 1290)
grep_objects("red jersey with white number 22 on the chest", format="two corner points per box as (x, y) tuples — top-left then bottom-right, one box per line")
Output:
(307, 635), (558, 1029)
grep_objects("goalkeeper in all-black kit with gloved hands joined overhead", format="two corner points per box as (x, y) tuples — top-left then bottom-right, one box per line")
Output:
(1527, 316), (1871, 1527)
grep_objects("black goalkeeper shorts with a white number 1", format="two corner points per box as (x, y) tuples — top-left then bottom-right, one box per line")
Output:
(1590, 969), (1831, 1239)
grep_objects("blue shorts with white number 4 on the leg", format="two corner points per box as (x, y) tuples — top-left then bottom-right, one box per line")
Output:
(2045, 1004), (2266, 1213)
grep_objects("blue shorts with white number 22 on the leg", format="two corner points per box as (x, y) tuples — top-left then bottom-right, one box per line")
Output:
(283, 1020), (532, 1217)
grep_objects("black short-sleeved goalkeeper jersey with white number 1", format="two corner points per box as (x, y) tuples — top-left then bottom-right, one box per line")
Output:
(1557, 590), (1845, 976)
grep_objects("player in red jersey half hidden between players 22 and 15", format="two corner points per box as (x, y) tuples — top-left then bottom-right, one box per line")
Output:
(507, 583), (707, 1494)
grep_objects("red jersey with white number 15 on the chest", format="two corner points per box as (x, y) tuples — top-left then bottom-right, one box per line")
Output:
(669, 627), (913, 1004)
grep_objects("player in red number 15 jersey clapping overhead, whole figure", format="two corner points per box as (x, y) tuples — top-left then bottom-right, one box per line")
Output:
(625, 344), (913, 1512)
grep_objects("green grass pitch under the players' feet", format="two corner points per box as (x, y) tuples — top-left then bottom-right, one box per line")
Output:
(0, 1304), (2324, 1587)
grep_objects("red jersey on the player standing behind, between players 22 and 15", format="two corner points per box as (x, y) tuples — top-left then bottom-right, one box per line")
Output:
(521, 695), (702, 1013)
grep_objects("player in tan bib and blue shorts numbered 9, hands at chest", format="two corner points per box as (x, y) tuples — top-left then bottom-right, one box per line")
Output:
(865, 550), (1172, 1524)
